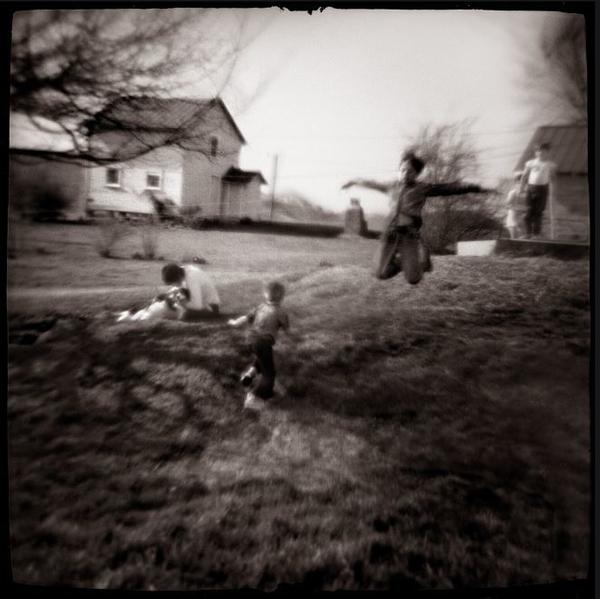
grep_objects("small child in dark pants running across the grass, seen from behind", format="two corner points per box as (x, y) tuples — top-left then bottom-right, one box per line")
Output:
(228, 281), (289, 410)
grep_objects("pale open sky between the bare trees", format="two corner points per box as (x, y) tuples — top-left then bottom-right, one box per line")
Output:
(189, 8), (572, 212)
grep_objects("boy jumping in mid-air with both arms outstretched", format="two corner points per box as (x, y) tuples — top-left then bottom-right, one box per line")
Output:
(342, 151), (486, 285)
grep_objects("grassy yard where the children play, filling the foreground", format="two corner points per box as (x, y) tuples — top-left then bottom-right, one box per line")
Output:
(8, 226), (590, 590)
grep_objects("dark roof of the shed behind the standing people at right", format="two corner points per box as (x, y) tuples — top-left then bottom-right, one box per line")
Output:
(515, 125), (588, 175)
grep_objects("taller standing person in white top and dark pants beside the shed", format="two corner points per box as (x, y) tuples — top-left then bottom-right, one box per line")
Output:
(520, 143), (556, 239)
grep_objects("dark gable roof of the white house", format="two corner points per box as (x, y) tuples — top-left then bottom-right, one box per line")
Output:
(92, 96), (246, 144)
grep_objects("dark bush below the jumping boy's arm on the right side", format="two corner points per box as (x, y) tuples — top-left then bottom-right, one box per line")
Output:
(421, 196), (503, 253)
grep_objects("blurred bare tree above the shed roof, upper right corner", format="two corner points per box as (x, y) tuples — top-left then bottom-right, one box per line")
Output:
(522, 13), (588, 124)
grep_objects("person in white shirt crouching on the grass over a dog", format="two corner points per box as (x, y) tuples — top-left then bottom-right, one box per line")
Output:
(162, 262), (221, 318)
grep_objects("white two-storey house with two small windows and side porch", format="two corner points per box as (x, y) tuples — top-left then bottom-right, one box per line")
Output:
(11, 98), (266, 219)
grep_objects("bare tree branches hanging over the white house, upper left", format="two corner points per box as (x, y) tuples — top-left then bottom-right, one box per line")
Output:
(10, 9), (251, 163)
